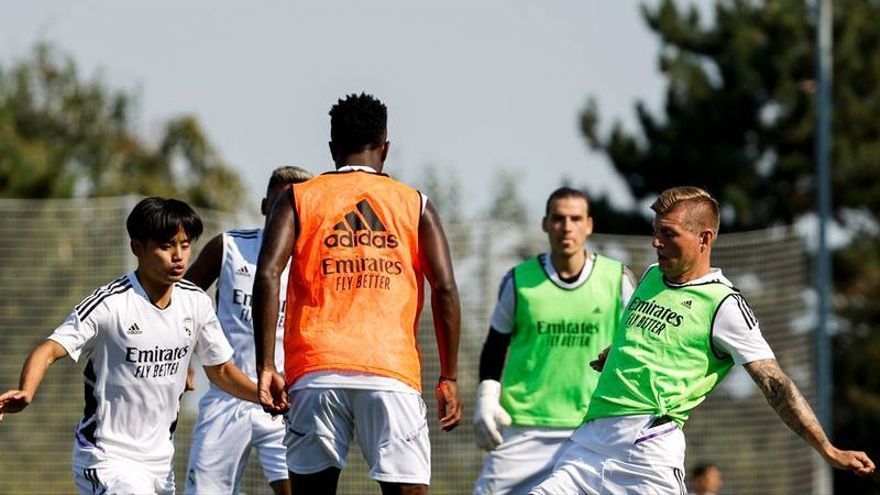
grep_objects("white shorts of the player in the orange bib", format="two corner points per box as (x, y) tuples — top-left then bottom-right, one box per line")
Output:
(284, 388), (431, 485)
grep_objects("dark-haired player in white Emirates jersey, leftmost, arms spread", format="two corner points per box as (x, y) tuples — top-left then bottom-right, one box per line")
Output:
(0, 198), (257, 494)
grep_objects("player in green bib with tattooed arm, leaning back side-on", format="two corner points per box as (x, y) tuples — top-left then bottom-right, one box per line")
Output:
(530, 187), (874, 495)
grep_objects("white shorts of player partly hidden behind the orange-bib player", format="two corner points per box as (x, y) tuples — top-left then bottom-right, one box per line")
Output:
(186, 392), (287, 495)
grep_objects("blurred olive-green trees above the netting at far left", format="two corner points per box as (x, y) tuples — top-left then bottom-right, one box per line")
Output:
(0, 44), (245, 211)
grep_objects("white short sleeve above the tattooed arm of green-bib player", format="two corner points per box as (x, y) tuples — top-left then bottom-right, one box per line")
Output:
(712, 294), (775, 364)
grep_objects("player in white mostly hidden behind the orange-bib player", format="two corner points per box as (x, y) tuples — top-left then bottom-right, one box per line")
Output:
(186, 167), (312, 495)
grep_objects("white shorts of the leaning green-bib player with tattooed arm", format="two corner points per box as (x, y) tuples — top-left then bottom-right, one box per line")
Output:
(529, 416), (687, 495)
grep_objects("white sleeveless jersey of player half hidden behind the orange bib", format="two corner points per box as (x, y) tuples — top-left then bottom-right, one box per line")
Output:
(217, 229), (289, 384)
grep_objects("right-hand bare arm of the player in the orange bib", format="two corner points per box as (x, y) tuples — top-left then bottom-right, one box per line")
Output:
(419, 201), (462, 431)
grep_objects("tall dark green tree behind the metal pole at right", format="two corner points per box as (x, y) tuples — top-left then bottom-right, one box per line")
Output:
(580, 0), (880, 493)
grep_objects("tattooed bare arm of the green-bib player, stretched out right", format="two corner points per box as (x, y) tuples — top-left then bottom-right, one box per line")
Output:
(745, 359), (874, 476)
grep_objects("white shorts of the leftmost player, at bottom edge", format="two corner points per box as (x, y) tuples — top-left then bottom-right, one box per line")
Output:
(73, 450), (174, 495)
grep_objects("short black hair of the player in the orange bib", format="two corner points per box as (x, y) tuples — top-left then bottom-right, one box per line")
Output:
(330, 93), (388, 153)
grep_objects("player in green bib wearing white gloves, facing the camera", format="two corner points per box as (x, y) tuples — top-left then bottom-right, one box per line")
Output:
(474, 187), (634, 495)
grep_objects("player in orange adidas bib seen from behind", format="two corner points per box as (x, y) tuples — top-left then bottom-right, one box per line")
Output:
(254, 94), (462, 495)
